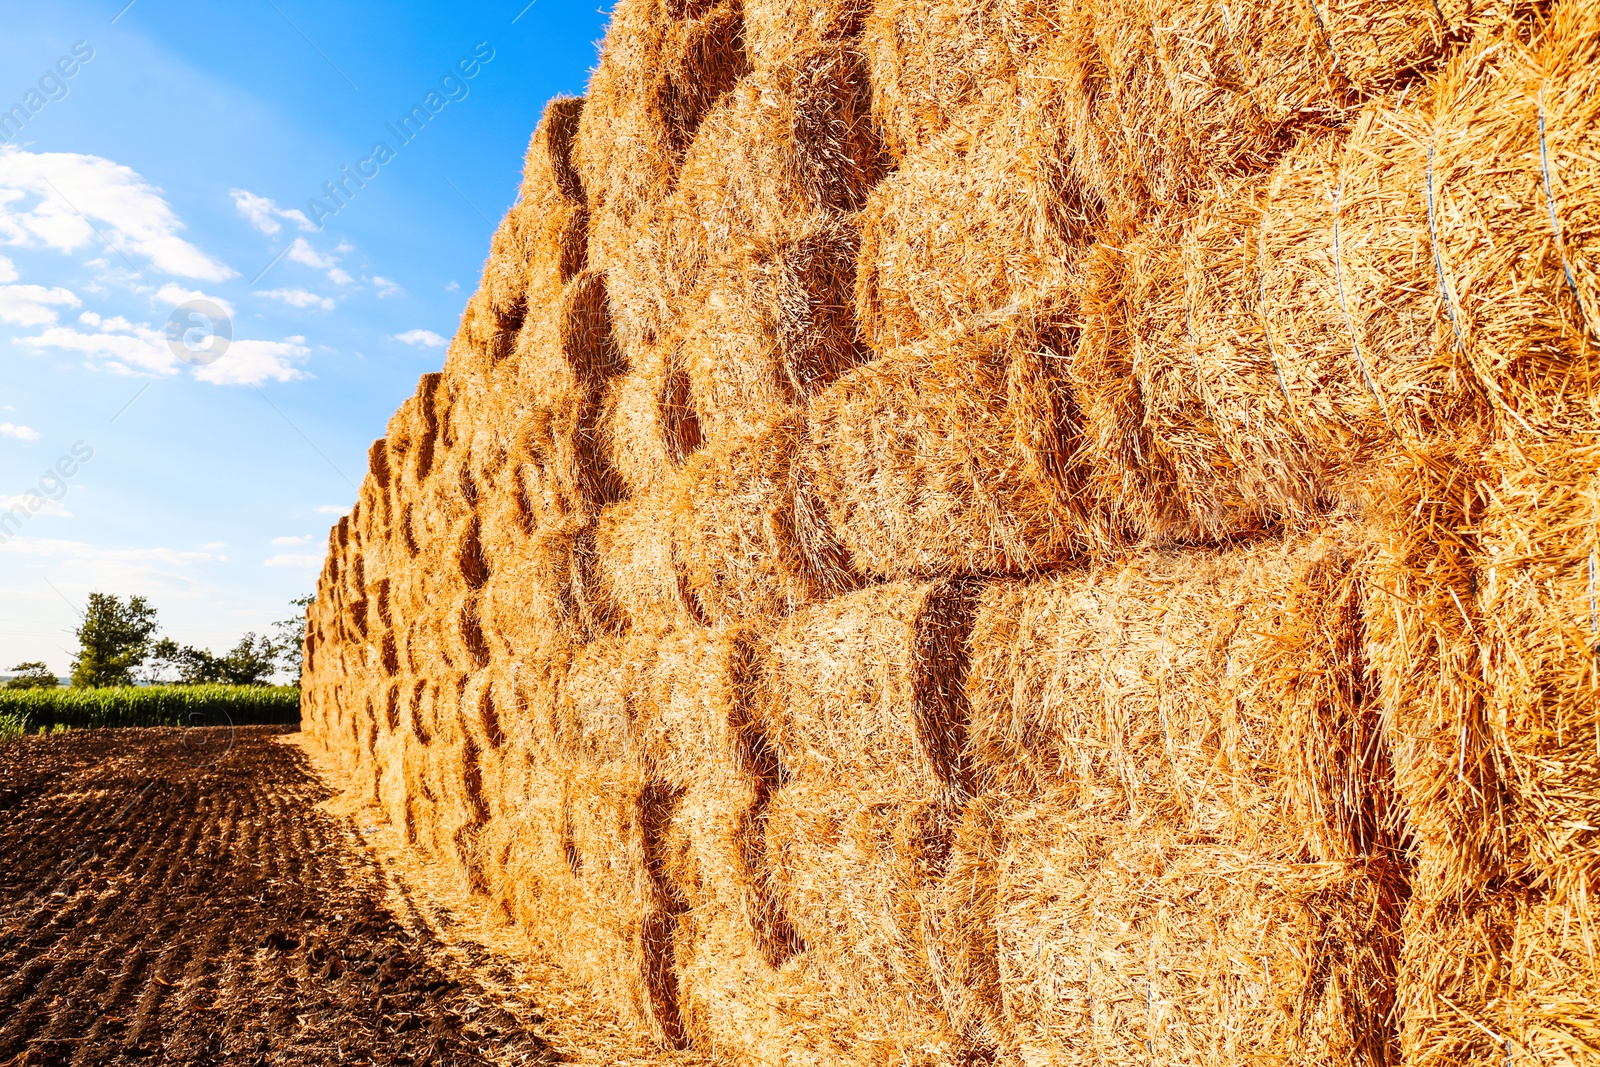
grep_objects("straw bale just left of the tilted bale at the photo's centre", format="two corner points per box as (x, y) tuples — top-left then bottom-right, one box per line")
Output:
(666, 413), (856, 622)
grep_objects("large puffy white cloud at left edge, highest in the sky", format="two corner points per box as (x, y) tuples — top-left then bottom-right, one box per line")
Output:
(0, 149), (237, 282)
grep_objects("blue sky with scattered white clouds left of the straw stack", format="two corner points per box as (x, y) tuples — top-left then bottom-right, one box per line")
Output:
(0, 0), (606, 673)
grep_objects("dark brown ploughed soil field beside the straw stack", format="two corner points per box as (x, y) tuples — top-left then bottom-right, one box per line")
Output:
(0, 726), (558, 1067)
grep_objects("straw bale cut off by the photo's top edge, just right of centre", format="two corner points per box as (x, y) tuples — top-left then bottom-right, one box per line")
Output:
(862, 0), (1059, 158)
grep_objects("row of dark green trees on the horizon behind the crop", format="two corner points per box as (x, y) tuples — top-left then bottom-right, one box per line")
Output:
(6, 593), (312, 689)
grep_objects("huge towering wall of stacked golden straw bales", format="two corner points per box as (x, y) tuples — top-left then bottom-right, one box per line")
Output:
(304, 0), (1600, 1067)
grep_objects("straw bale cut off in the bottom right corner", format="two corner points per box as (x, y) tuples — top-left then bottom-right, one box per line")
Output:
(1398, 886), (1600, 1067)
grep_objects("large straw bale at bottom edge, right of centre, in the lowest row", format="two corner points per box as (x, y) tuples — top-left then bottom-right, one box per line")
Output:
(995, 800), (1398, 1067)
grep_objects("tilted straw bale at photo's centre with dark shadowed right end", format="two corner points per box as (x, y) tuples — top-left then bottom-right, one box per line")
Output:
(802, 312), (1117, 579)
